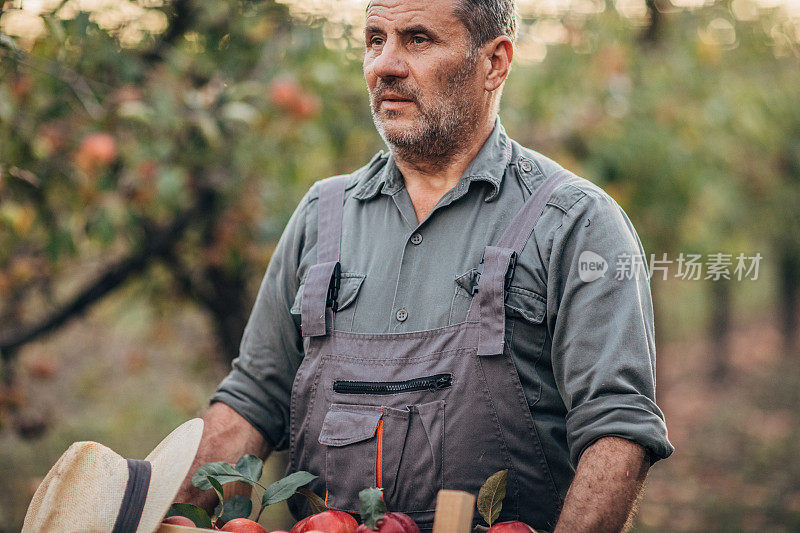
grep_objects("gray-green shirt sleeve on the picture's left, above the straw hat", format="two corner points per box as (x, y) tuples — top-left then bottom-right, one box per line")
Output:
(211, 193), (310, 450)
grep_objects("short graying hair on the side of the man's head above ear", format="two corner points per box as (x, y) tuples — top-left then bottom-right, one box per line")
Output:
(454, 0), (517, 52)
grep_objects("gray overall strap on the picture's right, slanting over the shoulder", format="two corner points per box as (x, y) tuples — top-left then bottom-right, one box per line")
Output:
(470, 170), (572, 355)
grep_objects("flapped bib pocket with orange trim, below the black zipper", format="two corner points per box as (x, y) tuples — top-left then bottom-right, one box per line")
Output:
(319, 401), (445, 513)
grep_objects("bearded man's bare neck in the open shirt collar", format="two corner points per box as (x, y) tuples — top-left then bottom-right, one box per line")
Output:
(394, 115), (494, 222)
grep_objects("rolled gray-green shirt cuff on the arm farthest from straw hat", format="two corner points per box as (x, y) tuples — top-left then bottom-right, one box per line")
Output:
(567, 394), (675, 466)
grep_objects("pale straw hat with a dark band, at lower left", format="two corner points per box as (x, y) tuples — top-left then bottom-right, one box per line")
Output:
(22, 418), (203, 533)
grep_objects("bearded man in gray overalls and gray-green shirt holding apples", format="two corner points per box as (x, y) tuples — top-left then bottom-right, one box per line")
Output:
(178, 0), (672, 532)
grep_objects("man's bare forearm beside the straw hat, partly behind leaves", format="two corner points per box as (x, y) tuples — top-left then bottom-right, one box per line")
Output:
(175, 402), (272, 513)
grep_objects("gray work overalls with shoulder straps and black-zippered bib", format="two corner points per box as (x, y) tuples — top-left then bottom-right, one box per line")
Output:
(289, 171), (571, 529)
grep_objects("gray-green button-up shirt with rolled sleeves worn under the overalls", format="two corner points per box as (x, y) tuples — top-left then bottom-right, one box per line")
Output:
(212, 120), (673, 494)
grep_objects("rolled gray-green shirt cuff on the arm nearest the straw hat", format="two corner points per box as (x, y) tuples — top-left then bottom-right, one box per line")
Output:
(209, 366), (288, 451)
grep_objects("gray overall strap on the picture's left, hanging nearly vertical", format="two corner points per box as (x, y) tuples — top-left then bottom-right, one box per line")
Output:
(300, 176), (347, 337)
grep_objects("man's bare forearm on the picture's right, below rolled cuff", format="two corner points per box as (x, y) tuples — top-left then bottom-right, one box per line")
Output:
(554, 437), (650, 533)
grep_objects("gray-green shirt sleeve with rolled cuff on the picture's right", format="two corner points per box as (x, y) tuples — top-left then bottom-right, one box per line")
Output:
(548, 189), (673, 465)
